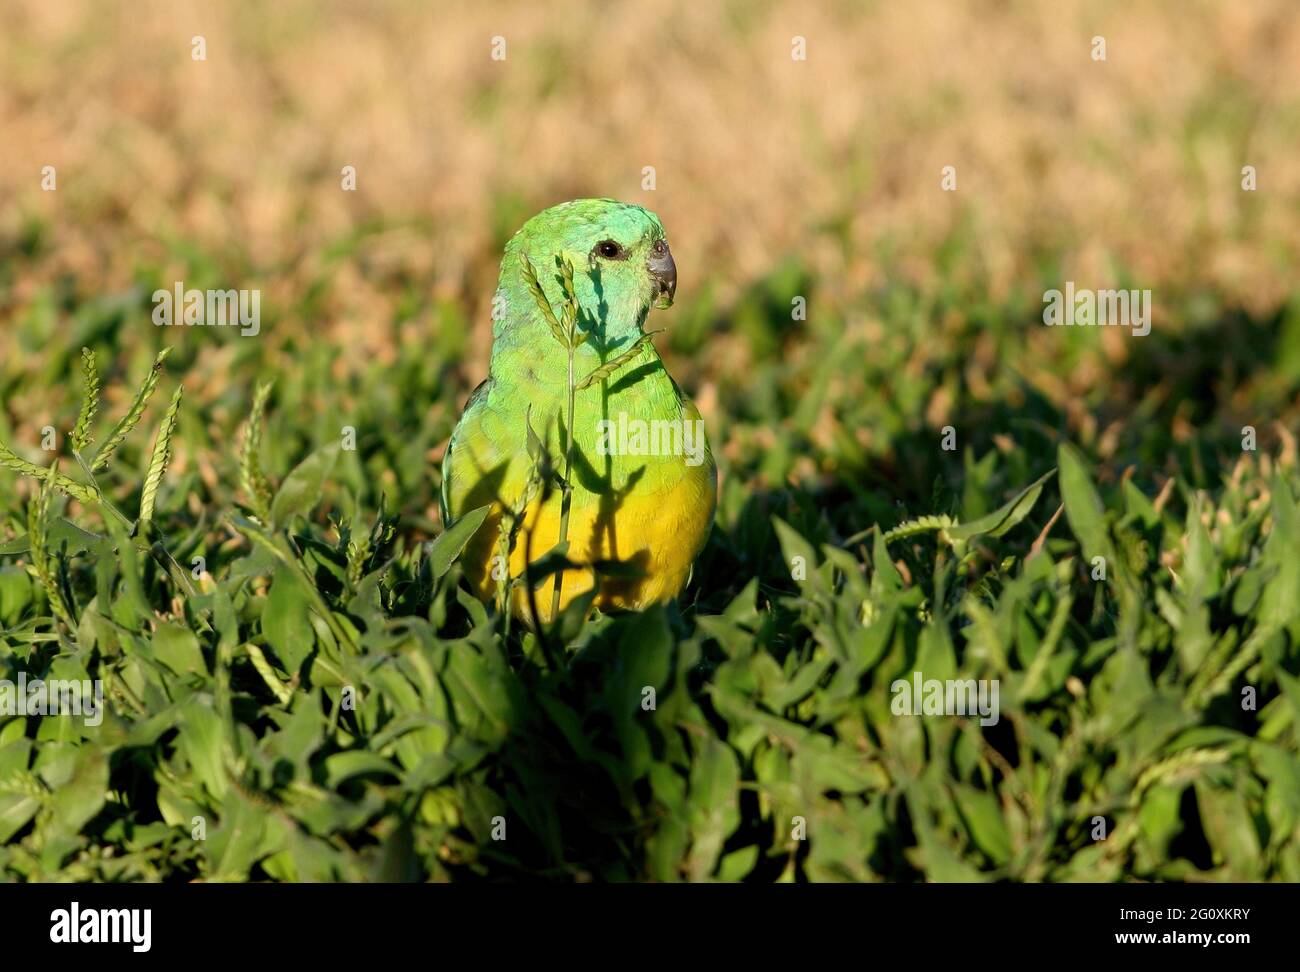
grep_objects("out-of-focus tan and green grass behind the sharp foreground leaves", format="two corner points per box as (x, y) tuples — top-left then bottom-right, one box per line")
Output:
(0, 0), (1300, 530)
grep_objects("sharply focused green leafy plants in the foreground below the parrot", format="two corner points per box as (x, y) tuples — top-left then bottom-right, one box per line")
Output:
(0, 343), (1300, 881)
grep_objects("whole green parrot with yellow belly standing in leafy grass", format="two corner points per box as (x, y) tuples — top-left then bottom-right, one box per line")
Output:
(442, 199), (718, 622)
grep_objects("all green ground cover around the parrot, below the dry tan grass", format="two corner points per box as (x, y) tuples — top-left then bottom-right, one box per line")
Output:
(0, 244), (1300, 881)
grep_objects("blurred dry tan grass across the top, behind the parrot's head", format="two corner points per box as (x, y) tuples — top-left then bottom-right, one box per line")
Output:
(0, 0), (1300, 462)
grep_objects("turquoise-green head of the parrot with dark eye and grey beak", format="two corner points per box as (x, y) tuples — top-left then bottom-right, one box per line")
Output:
(494, 199), (677, 344)
